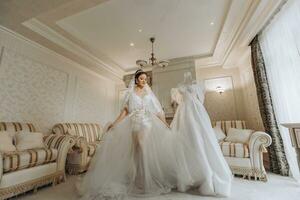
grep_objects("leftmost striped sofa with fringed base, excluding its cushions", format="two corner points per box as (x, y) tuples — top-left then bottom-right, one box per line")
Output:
(0, 122), (75, 199)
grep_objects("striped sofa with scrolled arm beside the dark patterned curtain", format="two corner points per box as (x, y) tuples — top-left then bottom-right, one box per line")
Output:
(213, 120), (272, 181)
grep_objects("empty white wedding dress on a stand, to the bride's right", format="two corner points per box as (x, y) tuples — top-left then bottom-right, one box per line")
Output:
(171, 72), (232, 196)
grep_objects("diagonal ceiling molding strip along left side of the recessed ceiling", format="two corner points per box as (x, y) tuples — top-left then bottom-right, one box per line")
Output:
(22, 18), (124, 79)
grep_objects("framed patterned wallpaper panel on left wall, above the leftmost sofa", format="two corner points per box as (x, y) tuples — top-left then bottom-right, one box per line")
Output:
(0, 48), (68, 131)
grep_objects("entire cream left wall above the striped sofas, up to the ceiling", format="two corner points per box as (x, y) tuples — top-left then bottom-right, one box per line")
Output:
(0, 26), (117, 132)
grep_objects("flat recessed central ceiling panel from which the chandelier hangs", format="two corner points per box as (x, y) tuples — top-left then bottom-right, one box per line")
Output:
(57, 0), (230, 70)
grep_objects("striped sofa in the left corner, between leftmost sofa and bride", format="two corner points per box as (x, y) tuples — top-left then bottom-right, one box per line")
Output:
(52, 123), (104, 174)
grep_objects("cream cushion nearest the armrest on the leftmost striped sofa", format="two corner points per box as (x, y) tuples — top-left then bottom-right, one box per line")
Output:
(16, 131), (45, 151)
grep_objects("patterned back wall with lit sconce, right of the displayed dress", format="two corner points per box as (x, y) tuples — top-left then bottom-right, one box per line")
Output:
(196, 67), (248, 124)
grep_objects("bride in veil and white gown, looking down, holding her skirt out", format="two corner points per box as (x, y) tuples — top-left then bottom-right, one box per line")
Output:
(79, 70), (180, 200)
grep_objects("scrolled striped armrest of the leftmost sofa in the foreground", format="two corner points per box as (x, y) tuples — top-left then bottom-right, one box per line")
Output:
(44, 134), (75, 171)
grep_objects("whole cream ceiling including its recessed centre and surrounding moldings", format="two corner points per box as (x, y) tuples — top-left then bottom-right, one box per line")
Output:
(0, 0), (284, 79)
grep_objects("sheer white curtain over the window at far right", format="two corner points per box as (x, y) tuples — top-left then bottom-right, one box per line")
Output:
(259, 0), (300, 181)
